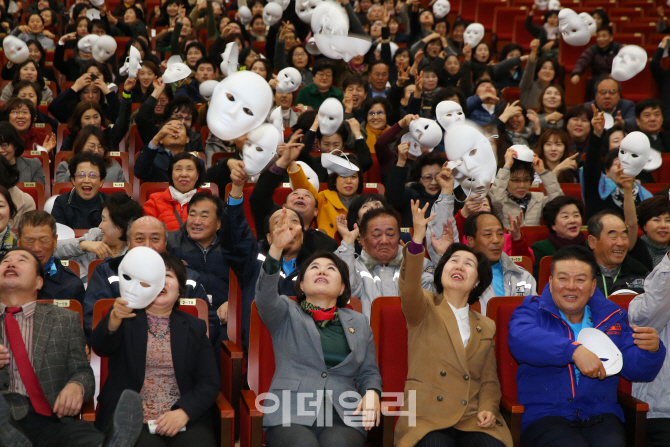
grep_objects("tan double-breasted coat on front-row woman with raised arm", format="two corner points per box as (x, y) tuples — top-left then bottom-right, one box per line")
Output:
(395, 247), (512, 447)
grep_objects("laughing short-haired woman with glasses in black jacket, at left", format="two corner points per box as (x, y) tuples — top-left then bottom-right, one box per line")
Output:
(51, 152), (107, 229)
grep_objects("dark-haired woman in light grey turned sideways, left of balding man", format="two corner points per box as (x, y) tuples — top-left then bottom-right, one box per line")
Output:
(56, 192), (143, 283)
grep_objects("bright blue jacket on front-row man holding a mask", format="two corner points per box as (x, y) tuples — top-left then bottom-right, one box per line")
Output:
(509, 285), (665, 430)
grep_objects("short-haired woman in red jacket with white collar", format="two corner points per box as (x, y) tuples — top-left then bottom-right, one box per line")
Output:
(144, 152), (205, 231)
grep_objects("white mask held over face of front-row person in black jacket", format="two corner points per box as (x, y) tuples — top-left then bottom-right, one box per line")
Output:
(119, 247), (165, 309)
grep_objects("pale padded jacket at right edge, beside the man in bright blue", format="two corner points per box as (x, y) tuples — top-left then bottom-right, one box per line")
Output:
(628, 256), (670, 418)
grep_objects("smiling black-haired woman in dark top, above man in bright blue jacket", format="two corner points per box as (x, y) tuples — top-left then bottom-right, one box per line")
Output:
(531, 196), (586, 280)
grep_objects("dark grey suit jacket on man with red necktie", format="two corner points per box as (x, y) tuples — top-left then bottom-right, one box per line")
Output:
(0, 304), (95, 420)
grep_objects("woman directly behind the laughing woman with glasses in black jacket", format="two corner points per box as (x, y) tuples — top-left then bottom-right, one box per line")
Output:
(56, 125), (127, 182)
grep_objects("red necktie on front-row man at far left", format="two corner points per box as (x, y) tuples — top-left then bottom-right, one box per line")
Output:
(5, 307), (53, 416)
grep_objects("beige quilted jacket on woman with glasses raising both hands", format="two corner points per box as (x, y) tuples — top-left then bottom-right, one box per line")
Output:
(489, 168), (563, 228)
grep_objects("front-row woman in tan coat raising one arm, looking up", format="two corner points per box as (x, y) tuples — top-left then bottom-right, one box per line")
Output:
(395, 202), (512, 447)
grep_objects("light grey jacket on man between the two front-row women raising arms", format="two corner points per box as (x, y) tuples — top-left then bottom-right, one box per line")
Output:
(335, 241), (436, 321)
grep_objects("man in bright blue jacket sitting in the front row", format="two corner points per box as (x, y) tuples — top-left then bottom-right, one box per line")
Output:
(509, 246), (665, 447)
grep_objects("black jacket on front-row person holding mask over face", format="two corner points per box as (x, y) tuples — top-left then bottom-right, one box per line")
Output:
(91, 310), (221, 430)
